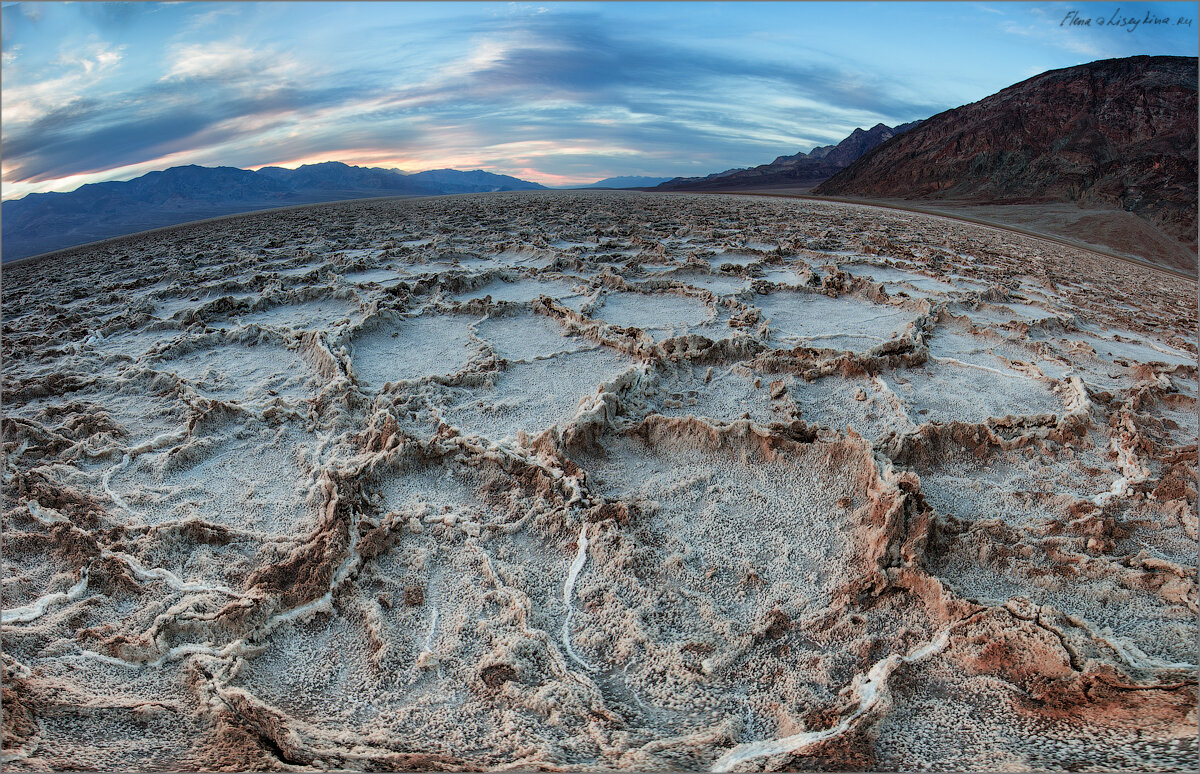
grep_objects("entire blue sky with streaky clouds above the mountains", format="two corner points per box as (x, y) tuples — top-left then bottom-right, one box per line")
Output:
(0, 1), (1200, 199)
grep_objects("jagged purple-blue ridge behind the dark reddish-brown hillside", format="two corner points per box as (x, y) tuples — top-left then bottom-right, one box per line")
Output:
(658, 121), (920, 191)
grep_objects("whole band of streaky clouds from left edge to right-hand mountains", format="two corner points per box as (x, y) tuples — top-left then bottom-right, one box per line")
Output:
(4, 6), (952, 194)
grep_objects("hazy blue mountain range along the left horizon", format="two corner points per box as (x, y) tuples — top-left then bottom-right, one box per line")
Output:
(0, 161), (545, 260)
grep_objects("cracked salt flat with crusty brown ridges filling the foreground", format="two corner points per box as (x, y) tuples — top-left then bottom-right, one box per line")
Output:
(2, 192), (1198, 770)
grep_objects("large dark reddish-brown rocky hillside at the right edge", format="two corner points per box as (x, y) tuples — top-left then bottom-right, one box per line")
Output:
(815, 56), (1196, 250)
